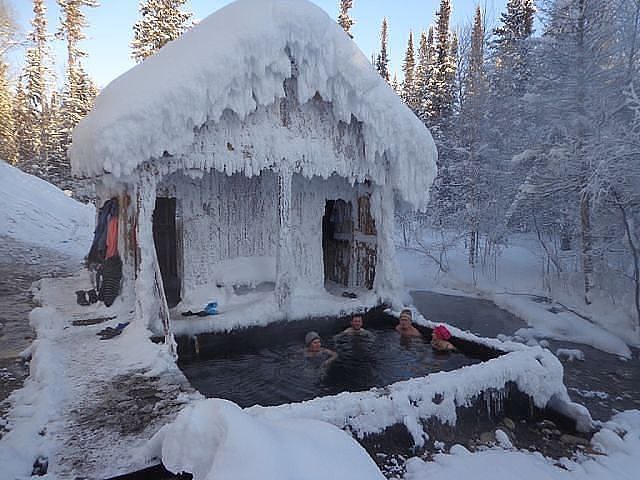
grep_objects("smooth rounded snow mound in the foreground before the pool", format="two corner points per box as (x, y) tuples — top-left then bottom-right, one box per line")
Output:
(150, 399), (384, 480)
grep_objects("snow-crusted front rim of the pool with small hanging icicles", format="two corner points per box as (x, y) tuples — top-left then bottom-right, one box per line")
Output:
(245, 347), (591, 447)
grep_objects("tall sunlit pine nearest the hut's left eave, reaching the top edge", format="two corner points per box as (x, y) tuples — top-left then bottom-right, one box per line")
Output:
(56, 0), (98, 187)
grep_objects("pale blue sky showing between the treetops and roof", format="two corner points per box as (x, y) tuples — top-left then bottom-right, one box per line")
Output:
(9, 0), (507, 87)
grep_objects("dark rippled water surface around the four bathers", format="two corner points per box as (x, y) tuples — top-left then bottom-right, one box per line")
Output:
(181, 326), (479, 407)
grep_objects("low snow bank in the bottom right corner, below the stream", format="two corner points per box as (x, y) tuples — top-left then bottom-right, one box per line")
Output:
(404, 410), (640, 480)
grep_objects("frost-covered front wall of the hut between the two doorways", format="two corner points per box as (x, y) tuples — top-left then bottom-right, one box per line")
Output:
(157, 171), (382, 292)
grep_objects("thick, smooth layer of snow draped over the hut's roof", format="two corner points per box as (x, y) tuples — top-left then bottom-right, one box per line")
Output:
(70, 0), (437, 207)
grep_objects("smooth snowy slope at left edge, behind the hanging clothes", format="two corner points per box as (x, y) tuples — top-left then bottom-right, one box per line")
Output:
(0, 160), (95, 256)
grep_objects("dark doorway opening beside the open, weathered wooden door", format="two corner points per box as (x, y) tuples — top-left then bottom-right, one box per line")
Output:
(322, 200), (353, 287)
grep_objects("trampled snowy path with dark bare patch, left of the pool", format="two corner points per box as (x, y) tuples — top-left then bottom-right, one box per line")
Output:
(0, 274), (199, 478)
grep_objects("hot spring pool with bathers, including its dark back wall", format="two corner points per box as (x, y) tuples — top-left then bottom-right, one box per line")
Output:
(179, 314), (483, 407)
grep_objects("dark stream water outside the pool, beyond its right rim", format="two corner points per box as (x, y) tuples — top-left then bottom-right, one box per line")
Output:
(411, 291), (640, 420)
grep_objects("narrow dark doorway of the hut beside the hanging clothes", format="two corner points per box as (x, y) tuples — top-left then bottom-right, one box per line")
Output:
(153, 197), (180, 308)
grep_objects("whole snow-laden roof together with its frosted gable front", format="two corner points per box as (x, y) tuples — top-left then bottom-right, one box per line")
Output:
(70, 0), (436, 212)
